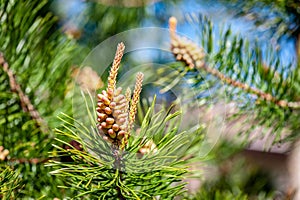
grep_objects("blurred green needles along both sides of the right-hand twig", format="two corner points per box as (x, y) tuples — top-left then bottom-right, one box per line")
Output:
(164, 15), (299, 145)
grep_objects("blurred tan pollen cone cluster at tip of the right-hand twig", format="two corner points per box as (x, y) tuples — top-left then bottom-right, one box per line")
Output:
(169, 17), (205, 69)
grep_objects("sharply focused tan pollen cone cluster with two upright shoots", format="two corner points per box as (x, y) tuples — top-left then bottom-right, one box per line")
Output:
(96, 43), (143, 148)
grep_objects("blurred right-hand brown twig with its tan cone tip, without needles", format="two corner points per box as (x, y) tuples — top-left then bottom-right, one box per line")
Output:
(169, 17), (300, 109)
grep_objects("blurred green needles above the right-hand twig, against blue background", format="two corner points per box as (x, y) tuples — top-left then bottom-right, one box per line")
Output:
(192, 16), (293, 100)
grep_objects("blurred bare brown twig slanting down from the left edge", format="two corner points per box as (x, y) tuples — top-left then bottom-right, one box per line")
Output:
(0, 52), (49, 132)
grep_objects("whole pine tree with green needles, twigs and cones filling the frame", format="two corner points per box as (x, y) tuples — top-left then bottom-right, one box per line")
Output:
(0, 0), (300, 199)
